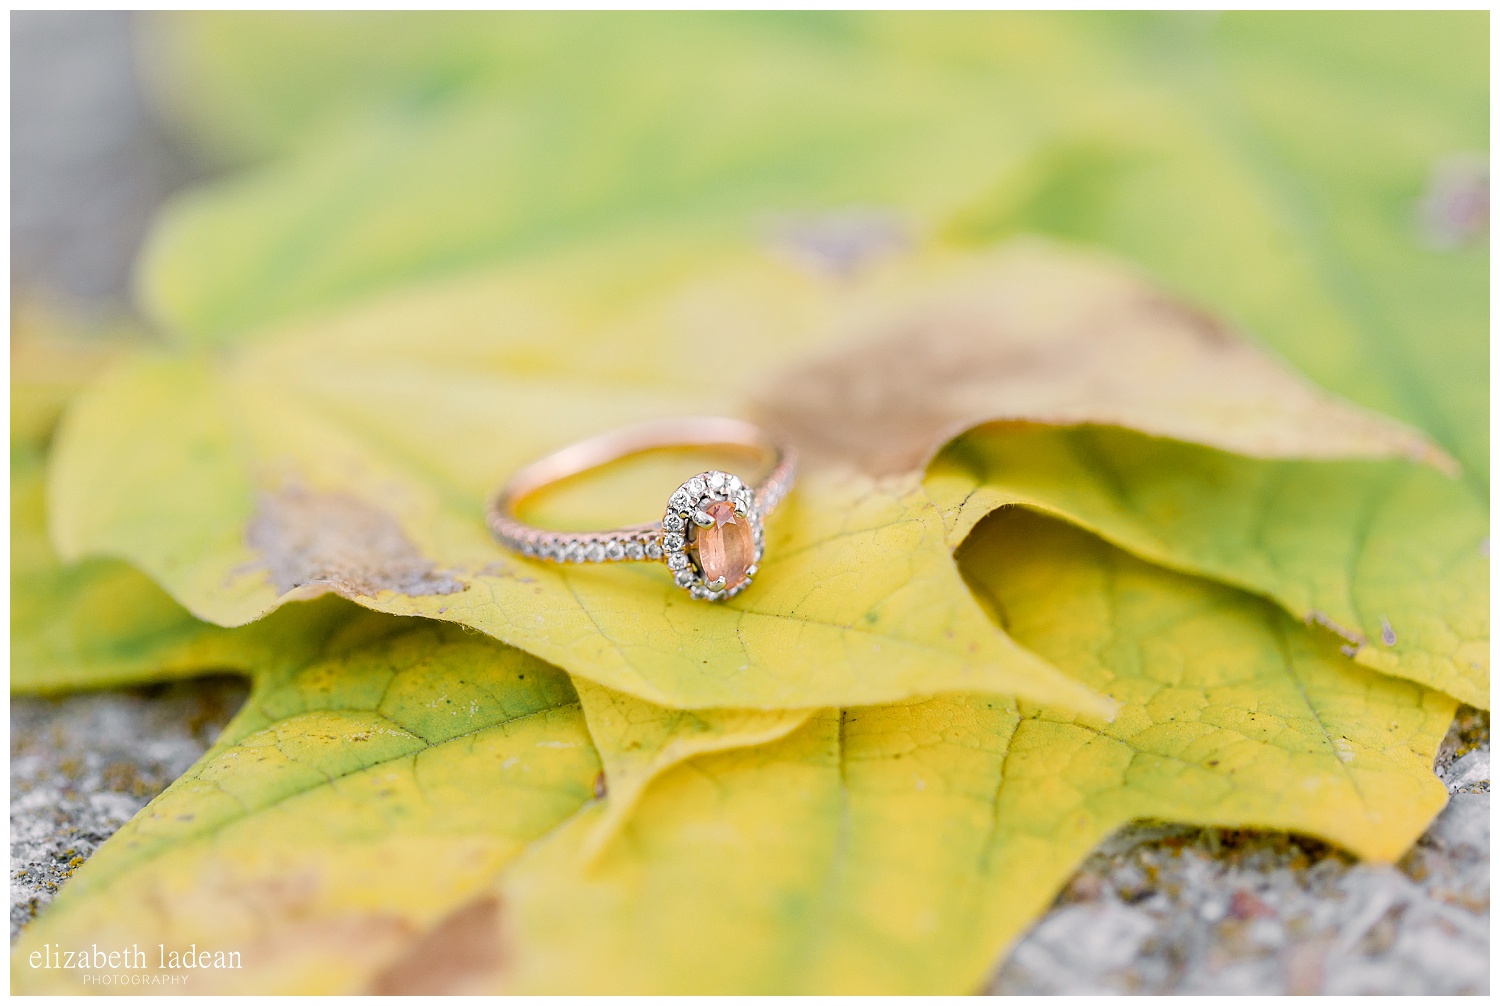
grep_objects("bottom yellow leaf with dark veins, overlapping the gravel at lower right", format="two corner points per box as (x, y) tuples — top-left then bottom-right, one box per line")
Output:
(495, 510), (1455, 994)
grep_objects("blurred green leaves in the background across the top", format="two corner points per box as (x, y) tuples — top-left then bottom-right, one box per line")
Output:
(21, 12), (1488, 498)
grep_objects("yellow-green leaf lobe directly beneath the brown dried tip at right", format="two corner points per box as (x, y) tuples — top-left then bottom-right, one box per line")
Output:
(926, 424), (1490, 709)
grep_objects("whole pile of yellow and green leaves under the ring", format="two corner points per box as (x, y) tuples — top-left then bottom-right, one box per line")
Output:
(11, 13), (1488, 993)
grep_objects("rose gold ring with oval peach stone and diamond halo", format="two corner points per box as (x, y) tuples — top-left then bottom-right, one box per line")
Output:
(486, 418), (797, 601)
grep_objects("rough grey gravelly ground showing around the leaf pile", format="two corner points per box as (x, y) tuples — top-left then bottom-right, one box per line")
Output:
(11, 12), (1490, 994)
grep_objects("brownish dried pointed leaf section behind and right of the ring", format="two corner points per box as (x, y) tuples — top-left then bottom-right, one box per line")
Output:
(759, 241), (1455, 475)
